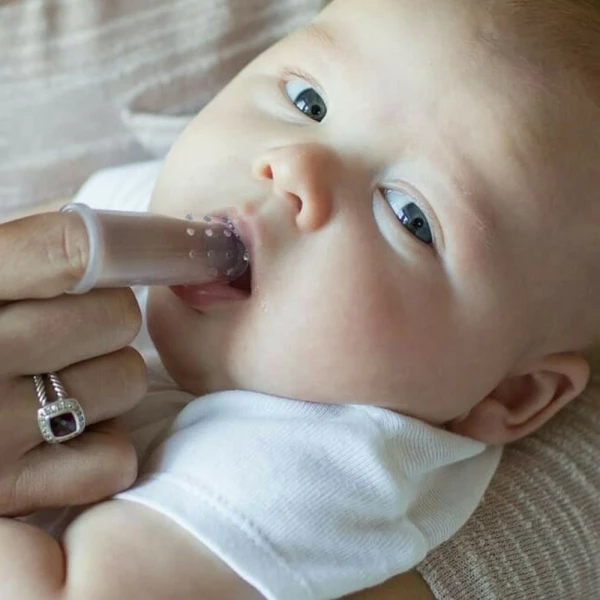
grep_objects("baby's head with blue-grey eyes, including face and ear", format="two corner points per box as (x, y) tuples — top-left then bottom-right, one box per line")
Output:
(148, 0), (600, 443)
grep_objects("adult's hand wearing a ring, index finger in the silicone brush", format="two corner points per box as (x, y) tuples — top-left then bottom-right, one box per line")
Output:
(0, 213), (146, 516)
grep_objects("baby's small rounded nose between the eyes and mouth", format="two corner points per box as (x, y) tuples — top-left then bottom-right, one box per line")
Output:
(253, 144), (339, 231)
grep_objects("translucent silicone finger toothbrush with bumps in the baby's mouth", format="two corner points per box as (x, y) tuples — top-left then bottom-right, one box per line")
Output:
(62, 203), (248, 294)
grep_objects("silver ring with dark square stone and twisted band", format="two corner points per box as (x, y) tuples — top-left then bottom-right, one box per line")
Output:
(33, 373), (85, 444)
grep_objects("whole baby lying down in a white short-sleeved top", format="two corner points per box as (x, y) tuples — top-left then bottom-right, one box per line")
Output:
(0, 0), (600, 600)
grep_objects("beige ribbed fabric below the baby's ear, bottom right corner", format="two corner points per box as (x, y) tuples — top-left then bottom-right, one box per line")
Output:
(420, 353), (600, 600)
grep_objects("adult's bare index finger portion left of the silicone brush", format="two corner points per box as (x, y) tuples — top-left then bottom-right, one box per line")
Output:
(0, 212), (89, 302)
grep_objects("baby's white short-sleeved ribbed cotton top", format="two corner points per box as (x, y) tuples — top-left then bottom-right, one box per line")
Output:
(65, 163), (501, 600)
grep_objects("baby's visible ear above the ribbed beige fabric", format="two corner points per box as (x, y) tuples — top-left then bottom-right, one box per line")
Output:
(447, 353), (590, 445)
